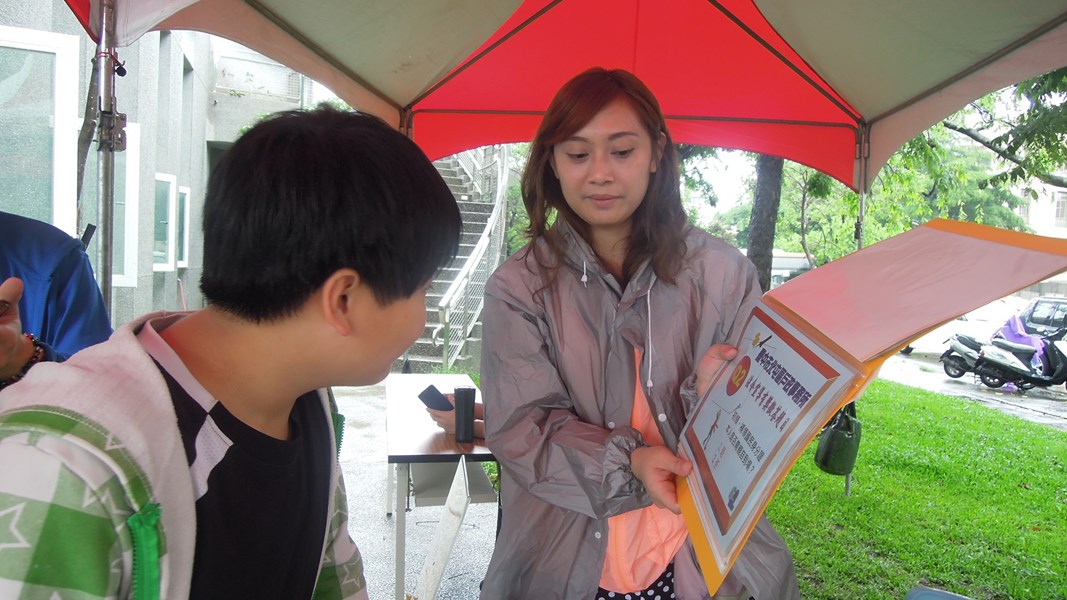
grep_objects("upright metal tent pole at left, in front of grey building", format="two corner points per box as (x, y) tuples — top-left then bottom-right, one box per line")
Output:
(96, 0), (124, 315)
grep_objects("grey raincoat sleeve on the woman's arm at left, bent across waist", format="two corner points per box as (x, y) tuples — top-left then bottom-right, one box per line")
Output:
(481, 277), (651, 518)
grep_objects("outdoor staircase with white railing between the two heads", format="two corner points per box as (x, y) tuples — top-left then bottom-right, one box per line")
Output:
(392, 146), (508, 373)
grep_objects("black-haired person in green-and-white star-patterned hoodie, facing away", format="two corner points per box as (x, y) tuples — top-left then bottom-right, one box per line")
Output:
(0, 109), (461, 599)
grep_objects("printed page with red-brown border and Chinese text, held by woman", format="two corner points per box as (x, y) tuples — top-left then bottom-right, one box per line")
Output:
(680, 303), (859, 574)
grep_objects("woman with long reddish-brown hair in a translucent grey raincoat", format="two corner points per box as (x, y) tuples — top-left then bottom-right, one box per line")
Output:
(481, 68), (799, 600)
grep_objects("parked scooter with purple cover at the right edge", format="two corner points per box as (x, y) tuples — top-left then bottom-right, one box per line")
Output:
(973, 317), (1067, 390)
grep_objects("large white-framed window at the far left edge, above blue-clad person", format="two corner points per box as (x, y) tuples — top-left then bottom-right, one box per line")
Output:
(0, 27), (79, 235)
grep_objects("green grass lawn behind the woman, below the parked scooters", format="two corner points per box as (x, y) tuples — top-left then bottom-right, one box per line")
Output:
(767, 380), (1067, 600)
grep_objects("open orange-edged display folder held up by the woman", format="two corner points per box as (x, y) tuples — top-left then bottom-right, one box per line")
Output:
(678, 219), (1067, 590)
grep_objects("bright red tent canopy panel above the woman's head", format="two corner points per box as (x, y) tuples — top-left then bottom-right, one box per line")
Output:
(410, 0), (862, 183)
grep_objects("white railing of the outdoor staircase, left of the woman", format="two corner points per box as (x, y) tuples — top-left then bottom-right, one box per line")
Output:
(434, 145), (508, 369)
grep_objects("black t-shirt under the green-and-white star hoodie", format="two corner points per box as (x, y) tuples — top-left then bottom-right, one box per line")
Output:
(160, 368), (333, 600)
